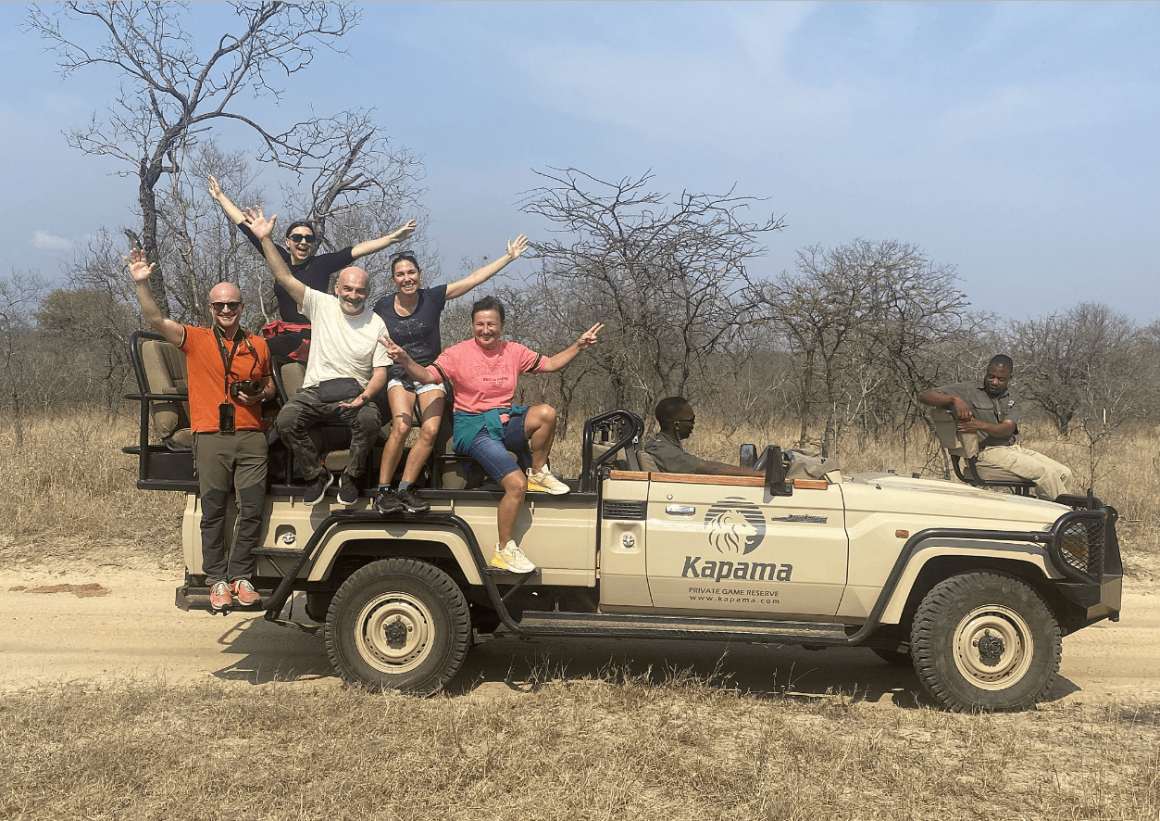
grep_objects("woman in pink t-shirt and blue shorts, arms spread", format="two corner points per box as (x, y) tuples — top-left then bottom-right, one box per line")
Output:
(380, 297), (604, 573)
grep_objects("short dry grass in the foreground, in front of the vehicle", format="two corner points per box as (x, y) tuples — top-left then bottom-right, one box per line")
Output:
(0, 674), (1160, 821)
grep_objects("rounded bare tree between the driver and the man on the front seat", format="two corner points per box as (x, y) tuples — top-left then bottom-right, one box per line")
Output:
(756, 239), (974, 456)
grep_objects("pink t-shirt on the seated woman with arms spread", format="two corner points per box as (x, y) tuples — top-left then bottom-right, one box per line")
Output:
(427, 339), (545, 413)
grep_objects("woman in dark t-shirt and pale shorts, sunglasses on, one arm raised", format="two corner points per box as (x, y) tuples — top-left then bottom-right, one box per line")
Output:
(375, 240), (528, 514)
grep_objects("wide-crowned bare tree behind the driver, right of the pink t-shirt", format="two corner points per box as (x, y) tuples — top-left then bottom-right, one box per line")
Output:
(523, 168), (784, 407)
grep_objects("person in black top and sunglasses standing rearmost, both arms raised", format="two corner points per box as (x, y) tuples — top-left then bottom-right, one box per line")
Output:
(209, 174), (415, 363)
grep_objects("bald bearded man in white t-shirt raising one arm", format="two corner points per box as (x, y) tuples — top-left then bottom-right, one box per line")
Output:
(246, 209), (393, 507)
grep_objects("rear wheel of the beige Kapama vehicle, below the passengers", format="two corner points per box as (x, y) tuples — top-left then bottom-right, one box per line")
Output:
(324, 559), (471, 695)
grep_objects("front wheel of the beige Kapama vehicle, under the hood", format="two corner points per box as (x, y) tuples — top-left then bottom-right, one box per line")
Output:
(911, 572), (1063, 712)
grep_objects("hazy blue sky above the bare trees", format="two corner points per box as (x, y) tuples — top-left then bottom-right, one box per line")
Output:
(0, 2), (1160, 322)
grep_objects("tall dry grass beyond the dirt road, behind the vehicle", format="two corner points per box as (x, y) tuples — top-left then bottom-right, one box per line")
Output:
(0, 409), (1160, 569)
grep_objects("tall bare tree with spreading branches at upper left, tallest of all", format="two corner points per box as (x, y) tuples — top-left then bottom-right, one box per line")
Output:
(27, 1), (358, 311)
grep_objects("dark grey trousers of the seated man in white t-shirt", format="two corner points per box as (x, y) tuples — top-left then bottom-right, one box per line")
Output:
(277, 387), (380, 481)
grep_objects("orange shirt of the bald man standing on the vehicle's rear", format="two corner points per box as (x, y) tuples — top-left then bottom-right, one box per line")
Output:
(181, 325), (270, 434)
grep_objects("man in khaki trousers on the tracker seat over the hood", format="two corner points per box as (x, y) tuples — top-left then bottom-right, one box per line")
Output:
(919, 354), (1072, 501)
